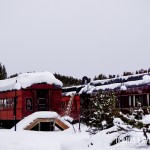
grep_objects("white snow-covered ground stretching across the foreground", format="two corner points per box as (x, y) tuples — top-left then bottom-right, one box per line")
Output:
(0, 124), (150, 150)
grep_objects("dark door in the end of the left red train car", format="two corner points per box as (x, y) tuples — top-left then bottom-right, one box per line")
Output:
(37, 90), (48, 111)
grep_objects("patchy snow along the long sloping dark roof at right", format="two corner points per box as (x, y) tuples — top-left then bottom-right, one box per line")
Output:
(63, 73), (150, 96)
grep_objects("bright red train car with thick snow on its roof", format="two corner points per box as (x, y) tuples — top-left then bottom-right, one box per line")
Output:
(0, 72), (62, 128)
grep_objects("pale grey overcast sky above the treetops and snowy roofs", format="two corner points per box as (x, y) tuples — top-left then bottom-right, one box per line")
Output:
(0, 0), (150, 78)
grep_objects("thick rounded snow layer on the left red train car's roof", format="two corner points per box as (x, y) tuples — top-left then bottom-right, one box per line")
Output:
(0, 71), (63, 91)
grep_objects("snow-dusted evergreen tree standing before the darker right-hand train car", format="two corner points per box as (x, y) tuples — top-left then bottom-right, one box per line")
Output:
(81, 92), (117, 133)
